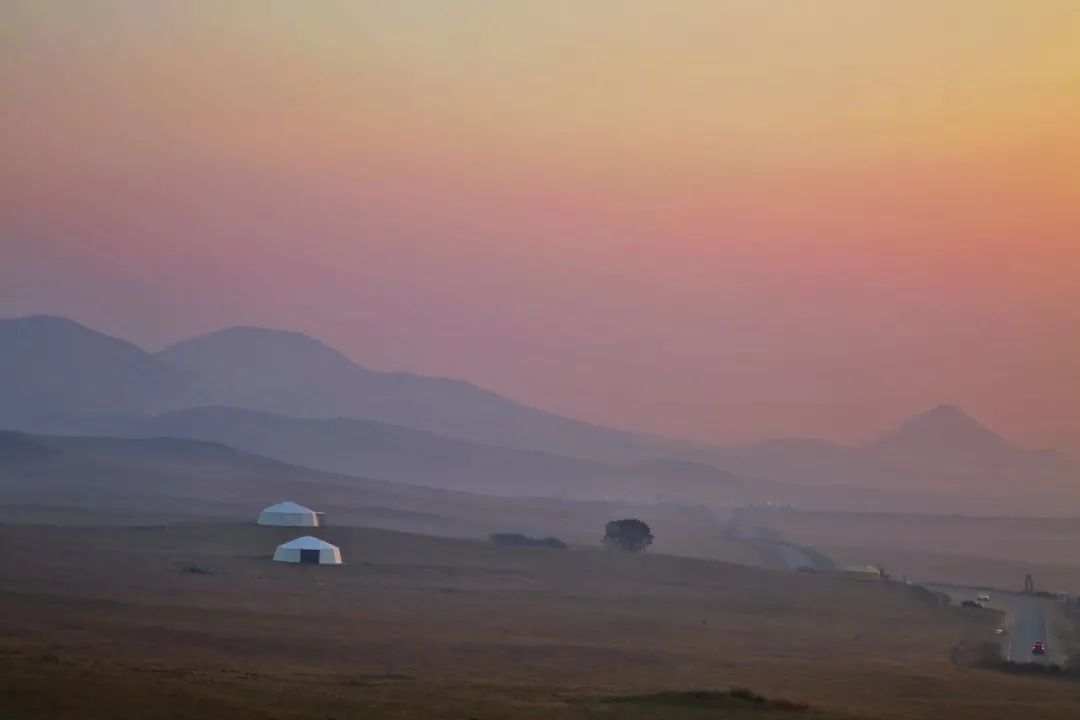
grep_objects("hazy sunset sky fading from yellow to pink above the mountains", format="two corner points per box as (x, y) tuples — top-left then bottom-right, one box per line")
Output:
(0, 0), (1080, 452)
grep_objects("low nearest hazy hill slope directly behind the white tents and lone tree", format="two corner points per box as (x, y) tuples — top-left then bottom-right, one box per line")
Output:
(0, 432), (786, 561)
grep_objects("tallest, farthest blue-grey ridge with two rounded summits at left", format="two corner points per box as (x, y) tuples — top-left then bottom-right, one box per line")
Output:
(0, 315), (693, 461)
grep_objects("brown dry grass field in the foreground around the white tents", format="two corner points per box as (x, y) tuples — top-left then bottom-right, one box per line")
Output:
(0, 524), (1080, 720)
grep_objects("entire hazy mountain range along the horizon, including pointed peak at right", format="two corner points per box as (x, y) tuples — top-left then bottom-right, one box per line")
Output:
(0, 315), (1080, 512)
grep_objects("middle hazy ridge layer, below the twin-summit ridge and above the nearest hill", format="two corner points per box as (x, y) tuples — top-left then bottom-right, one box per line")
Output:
(39, 407), (1028, 512)
